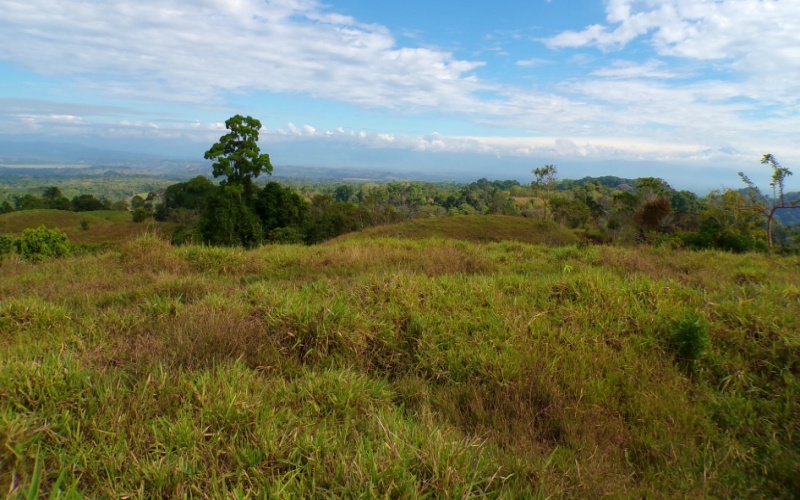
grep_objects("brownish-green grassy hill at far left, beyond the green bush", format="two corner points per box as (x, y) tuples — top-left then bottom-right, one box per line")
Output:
(0, 209), (173, 245)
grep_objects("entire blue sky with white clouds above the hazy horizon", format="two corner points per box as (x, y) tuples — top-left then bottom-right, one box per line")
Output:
(0, 0), (800, 190)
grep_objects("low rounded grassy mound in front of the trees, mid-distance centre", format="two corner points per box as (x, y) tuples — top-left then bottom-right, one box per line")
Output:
(342, 215), (578, 246)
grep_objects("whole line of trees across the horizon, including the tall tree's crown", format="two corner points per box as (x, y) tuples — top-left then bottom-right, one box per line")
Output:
(0, 115), (800, 252)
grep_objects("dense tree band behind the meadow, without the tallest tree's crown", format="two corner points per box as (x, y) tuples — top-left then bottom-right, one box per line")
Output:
(144, 170), (798, 252)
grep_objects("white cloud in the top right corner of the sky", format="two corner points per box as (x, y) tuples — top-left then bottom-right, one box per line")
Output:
(544, 0), (800, 103)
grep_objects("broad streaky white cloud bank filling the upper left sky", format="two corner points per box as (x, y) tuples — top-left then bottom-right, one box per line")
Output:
(0, 0), (482, 109)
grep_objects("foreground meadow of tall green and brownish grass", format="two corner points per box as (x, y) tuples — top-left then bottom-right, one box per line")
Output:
(0, 234), (800, 498)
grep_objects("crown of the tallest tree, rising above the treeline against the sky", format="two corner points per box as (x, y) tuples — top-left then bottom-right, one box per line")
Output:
(205, 115), (272, 186)
